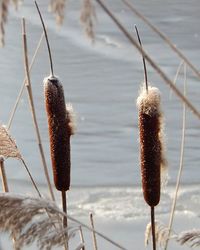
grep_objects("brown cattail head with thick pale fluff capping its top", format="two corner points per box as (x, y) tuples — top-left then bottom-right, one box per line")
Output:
(137, 86), (164, 207)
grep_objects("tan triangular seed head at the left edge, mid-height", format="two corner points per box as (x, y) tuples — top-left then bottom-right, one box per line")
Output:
(0, 125), (22, 160)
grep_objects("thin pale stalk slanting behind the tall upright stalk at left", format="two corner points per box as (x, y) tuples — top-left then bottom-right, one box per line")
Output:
(7, 33), (44, 130)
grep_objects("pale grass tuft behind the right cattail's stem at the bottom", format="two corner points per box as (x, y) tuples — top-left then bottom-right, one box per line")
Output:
(145, 221), (169, 247)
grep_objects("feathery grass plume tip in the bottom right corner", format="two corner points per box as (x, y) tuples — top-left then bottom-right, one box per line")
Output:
(176, 229), (200, 247)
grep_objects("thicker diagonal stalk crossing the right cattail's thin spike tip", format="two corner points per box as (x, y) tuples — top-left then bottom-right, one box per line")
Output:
(96, 0), (200, 119)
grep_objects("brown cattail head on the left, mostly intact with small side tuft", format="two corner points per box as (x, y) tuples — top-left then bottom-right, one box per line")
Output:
(44, 76), (72, 191)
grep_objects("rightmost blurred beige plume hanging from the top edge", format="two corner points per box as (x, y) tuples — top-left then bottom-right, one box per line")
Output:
(80, 0), (96, 41)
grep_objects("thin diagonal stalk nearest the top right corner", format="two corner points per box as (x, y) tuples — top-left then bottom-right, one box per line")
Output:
(121, 0), (200, 78)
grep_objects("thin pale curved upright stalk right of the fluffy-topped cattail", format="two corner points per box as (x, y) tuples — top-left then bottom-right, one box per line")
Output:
(165, 65), (187, 250)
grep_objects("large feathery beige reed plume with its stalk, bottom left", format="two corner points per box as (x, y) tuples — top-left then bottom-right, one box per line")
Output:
(0, 193), (127, 250)
